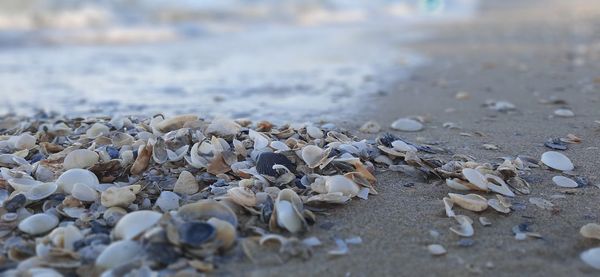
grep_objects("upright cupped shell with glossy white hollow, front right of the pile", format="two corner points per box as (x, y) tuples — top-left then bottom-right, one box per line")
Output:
(271, 189), (306, 233)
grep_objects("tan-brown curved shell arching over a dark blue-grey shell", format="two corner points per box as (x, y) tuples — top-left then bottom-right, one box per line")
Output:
(177, 199), (238, 227)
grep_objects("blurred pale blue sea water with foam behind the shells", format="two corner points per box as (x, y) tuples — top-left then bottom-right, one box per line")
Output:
(0, 0), (476, 120)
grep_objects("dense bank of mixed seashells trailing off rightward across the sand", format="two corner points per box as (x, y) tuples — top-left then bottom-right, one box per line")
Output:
(0, 115), (597, 276)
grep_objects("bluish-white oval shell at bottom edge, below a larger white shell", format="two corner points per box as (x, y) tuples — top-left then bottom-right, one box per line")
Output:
(96, 240), (144, 269)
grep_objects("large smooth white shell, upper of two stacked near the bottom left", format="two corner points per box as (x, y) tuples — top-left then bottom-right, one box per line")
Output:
(113, 211), (162, 240)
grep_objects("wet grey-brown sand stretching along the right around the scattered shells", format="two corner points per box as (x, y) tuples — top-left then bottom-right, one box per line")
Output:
(227, 0), (600, 276)
